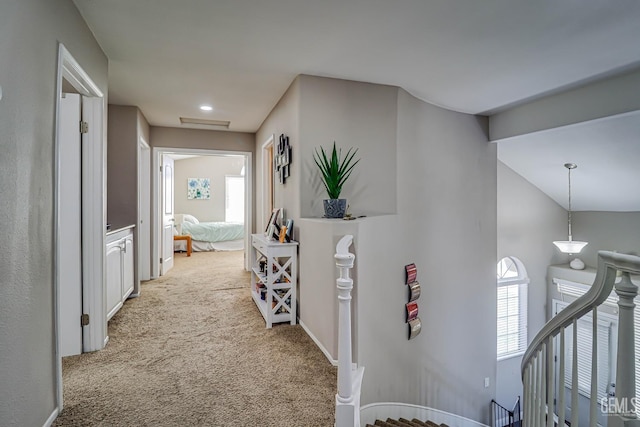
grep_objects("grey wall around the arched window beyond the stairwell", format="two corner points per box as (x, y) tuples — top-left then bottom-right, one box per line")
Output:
(494, 162), (568, 407)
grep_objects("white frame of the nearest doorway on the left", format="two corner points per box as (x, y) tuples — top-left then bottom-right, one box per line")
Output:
(53, 43), (107, 412)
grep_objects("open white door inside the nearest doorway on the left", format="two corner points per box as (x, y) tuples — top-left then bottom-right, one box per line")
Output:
(57, 93), (82, 356)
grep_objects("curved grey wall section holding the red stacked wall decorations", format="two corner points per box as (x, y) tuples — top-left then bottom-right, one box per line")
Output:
(358, 89), (496, 422)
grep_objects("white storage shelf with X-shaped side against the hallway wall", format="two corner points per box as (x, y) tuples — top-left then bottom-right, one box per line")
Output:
(251, 234), (298, 328)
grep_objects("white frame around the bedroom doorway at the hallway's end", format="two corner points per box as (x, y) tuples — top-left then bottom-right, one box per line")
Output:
(151, 147), (253, 279)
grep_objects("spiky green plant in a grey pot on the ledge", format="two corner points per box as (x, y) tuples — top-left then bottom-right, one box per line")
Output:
(313, 141), (360, 218)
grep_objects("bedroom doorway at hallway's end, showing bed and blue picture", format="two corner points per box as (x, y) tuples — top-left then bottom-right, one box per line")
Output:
(151, 147), (253, 278)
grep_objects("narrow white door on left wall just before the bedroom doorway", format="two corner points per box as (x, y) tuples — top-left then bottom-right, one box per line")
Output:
(134, 140), (151, 284)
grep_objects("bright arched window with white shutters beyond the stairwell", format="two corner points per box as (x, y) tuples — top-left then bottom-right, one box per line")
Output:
(497, 257), (529, 360)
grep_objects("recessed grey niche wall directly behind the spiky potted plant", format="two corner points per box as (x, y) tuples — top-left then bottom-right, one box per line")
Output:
(299, 75), (398, 218)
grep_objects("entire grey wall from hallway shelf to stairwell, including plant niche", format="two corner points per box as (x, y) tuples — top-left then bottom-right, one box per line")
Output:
(257, 76), (496, 422)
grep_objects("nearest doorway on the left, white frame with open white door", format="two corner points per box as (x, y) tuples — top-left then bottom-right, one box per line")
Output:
(54, 44), (107, 411)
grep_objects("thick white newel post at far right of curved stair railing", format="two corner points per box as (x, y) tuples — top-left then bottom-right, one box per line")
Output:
(615, 272), (638, 420)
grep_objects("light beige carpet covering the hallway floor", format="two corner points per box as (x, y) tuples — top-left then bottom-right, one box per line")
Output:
(54, 252), (336, 426)
